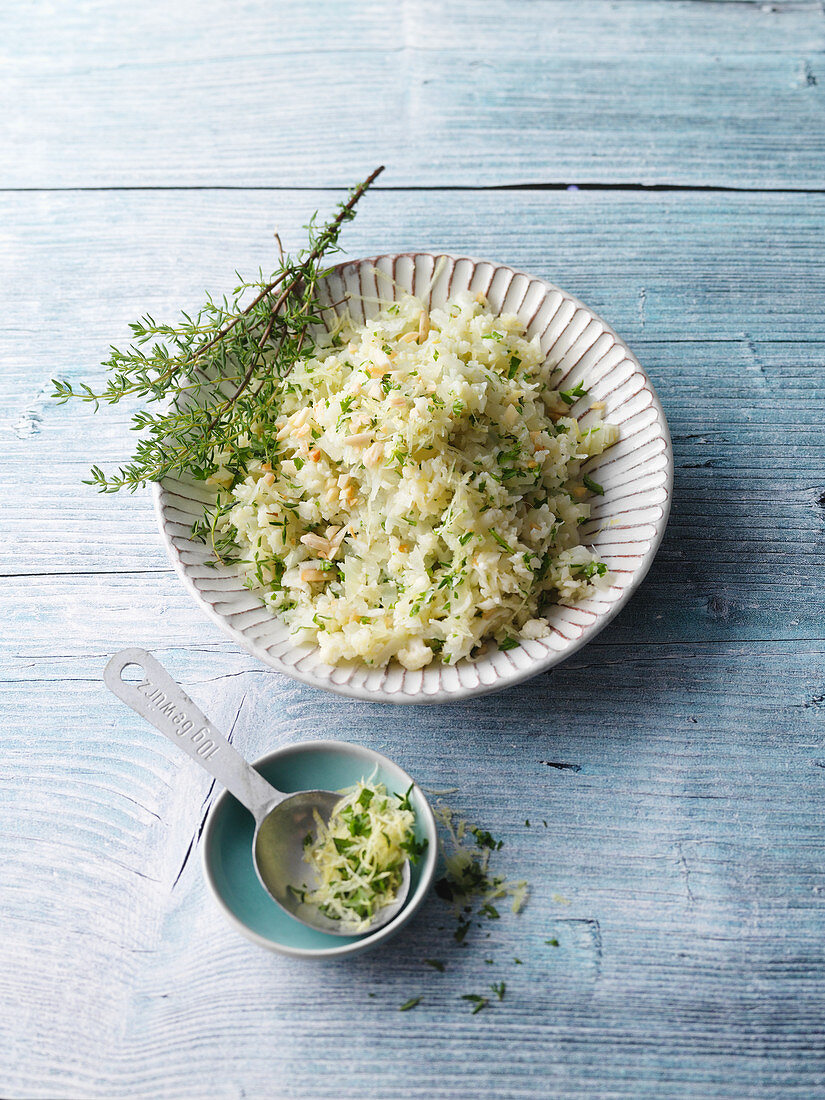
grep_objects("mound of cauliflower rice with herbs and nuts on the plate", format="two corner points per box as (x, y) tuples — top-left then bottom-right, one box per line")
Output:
(207, 293), (618, 669)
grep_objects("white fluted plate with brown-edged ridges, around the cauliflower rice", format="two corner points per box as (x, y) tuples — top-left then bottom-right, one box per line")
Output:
(154, 252), (673, 703)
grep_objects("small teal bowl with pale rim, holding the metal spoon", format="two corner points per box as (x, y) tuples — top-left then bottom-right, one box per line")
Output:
(201, 741), (438, 959)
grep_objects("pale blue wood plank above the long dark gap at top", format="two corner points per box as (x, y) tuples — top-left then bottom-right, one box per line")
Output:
(0, 0), (825, 188)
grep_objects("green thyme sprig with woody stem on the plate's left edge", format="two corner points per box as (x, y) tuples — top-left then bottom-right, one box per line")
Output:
(52, 167), (384, 493)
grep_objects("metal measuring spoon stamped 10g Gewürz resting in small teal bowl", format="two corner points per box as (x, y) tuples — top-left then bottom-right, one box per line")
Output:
(103, 649), (409, 936)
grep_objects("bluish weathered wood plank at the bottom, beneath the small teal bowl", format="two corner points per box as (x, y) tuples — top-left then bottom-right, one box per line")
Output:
(0, 644), (825, 1100)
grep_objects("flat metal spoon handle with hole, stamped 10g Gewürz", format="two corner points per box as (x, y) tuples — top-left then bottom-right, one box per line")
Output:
(103, 649), (285, 822)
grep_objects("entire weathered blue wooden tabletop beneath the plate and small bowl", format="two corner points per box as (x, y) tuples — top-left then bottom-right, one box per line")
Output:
(0, 0), (825, 1100)
